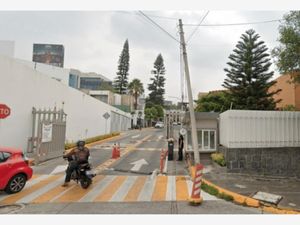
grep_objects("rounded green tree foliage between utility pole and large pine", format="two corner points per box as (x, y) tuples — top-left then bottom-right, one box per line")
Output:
(195, 91), (231, 112)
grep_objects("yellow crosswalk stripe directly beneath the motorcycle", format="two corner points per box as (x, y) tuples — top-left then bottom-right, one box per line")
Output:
(54, 175), (104, 202)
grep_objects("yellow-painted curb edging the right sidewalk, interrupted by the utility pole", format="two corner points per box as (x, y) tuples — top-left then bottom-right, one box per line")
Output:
(187, 157), (300, 214)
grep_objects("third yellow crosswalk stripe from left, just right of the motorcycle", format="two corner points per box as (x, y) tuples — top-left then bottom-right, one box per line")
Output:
(94, 176), (127, 202)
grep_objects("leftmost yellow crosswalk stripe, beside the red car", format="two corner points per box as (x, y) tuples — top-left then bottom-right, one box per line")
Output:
(1, 176), (61, 204)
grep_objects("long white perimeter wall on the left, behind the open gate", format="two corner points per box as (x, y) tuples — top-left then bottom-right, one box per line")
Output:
(0, 56), (131, 150)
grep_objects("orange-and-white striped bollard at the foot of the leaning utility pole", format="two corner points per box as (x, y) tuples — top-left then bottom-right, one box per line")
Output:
(189, 164), (204, 205)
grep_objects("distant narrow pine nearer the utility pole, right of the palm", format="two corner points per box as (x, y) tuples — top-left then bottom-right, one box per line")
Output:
(148, 54), (166, 106)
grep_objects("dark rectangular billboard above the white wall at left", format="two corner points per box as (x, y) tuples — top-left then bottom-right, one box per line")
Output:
(32, 44), (65, 67)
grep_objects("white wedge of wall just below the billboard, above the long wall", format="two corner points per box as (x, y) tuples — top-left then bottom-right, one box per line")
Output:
(15, 59), (70, 86)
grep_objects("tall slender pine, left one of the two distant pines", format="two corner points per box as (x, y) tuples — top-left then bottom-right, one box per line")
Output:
(113, 39), (129, 94)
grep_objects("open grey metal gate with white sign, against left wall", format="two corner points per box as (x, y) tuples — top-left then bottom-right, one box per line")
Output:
(27, 107), (67, 164)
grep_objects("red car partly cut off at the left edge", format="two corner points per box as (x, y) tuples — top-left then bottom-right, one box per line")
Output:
(0, 147), (32, 194)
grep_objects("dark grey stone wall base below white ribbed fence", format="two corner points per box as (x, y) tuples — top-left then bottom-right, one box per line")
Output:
(221, 148), (300, 178)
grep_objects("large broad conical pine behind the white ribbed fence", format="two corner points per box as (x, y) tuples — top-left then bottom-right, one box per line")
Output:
(223, 29), (281, 110)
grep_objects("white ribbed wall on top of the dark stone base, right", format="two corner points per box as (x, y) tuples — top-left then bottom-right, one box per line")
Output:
(220, 110), (300, 148)
